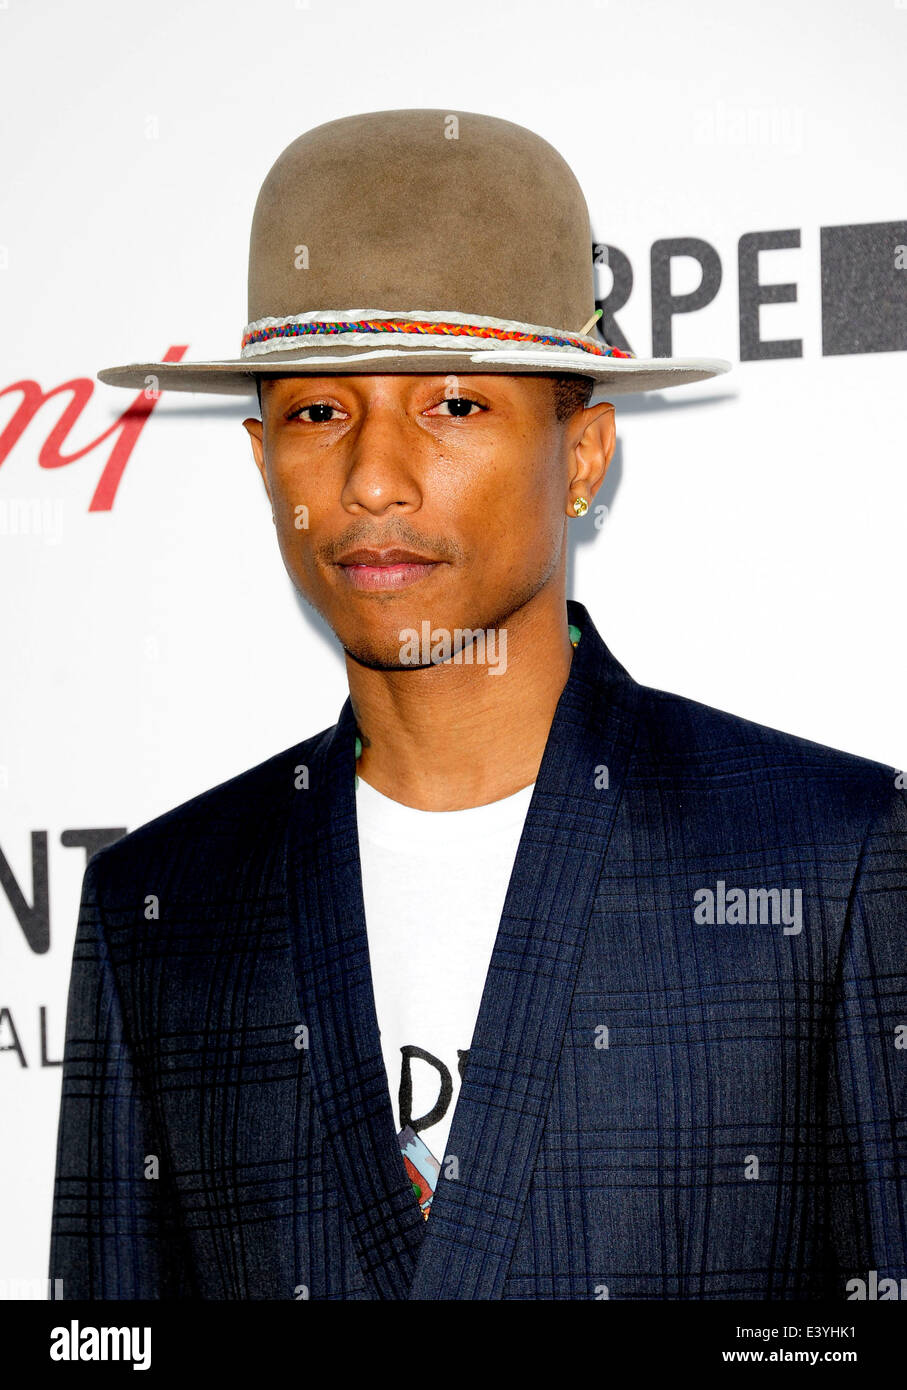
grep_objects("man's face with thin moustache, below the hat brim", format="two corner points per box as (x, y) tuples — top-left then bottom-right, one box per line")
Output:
(244, 374), (614, 669)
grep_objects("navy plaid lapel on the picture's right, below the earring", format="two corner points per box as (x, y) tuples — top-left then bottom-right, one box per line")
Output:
(408, 602), (640, 1300)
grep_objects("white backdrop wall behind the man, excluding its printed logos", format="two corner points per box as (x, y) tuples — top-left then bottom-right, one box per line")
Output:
(0, 0), (907, 1297)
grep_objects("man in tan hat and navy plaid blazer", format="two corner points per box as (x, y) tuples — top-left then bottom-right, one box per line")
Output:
(50, 111), (907, 1301)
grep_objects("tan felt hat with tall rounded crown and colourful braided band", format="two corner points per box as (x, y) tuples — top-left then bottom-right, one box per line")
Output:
(97, 110), (731, 396)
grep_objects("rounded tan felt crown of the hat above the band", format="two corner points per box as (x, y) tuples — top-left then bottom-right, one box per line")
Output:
(247, 110), (597, 338)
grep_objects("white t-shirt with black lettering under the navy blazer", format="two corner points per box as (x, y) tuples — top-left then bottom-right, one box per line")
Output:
(356, 777), (535, 1216)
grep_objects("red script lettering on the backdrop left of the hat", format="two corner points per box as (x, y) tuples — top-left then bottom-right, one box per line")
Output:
(0, 345), (188, 512)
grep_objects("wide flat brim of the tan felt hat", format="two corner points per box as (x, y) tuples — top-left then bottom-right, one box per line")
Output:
(97, 346), (731, 396)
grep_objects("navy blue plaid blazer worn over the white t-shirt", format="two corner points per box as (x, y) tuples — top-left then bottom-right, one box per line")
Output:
(50, 602), (907, 1300)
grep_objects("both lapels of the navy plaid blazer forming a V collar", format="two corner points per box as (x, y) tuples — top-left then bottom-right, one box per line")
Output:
(288, 600), (640, 1300)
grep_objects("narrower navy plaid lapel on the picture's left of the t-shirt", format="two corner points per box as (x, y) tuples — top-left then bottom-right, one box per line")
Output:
(288, 699), (425, 1298)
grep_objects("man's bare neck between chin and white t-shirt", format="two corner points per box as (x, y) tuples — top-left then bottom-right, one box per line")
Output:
(346, 589), (574, 810)
